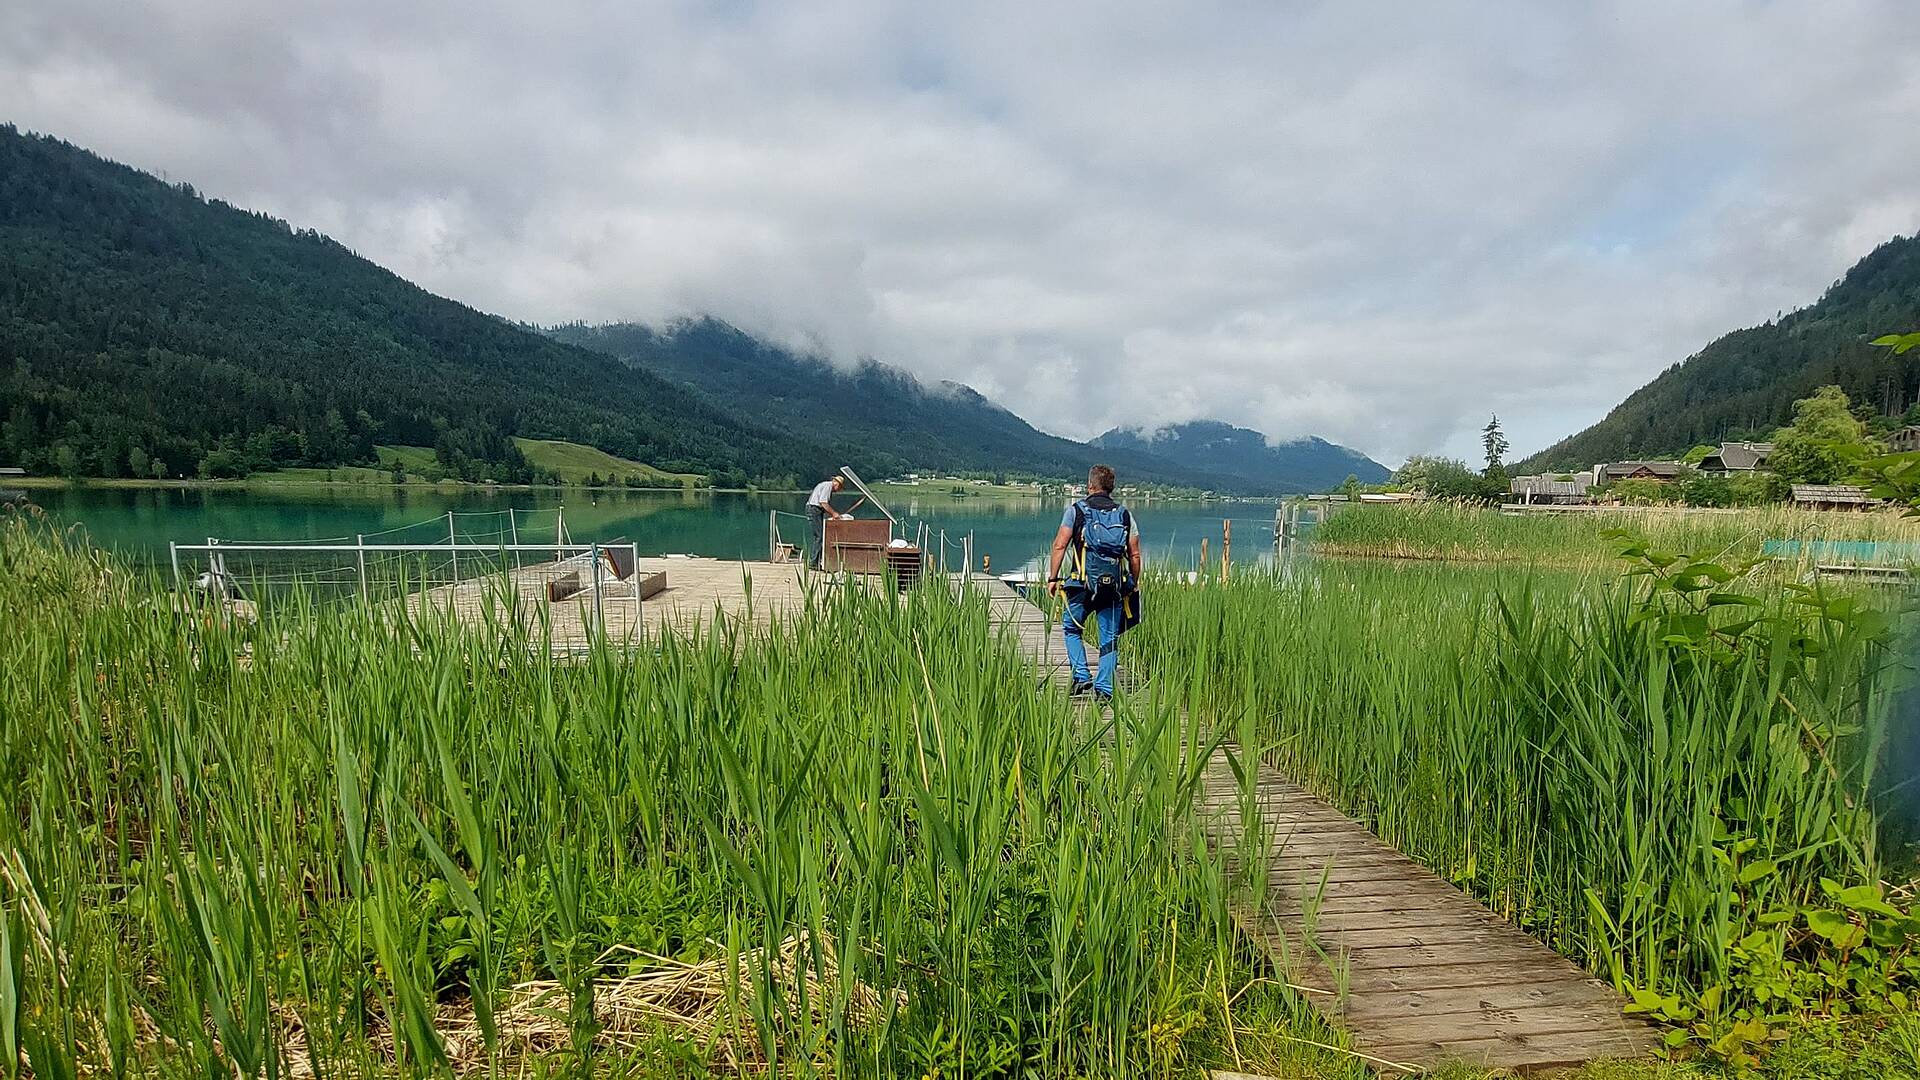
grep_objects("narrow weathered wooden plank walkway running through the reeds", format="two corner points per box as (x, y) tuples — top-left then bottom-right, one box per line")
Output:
(956, 575), (1657, 1070)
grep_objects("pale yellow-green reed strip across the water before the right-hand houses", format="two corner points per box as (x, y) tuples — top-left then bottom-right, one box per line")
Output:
(1308, 502), (1920, 569)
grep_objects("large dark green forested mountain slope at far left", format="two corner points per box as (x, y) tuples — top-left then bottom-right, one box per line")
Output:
(0, 125), (837, 484)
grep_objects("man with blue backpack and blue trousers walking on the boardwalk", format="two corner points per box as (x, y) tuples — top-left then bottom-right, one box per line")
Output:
(1046, 465), (1142, 701)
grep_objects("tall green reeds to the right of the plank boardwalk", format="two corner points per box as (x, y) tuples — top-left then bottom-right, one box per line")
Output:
(1137, 553), (1889, 990)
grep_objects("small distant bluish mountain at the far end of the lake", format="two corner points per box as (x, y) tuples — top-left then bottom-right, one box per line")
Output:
(1092, 421), (1392, 492)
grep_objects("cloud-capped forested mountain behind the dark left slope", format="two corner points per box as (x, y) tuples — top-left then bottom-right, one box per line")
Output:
(549, 319), (1279, 492)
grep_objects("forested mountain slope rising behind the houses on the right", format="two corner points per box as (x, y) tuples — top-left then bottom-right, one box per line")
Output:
(1515, 236), (1920, 471)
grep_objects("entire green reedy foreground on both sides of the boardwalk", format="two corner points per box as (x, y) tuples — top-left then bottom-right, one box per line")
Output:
(0, 517), (1920, 1080)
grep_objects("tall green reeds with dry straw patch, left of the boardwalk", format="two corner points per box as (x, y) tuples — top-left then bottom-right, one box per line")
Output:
(0, 519), (1361, 1078)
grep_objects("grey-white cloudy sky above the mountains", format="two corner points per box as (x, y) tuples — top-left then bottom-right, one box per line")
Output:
(0, 0), (1920, 463)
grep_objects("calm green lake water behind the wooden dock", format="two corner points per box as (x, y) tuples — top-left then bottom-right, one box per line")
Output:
(31, 484), (1273, 569)
